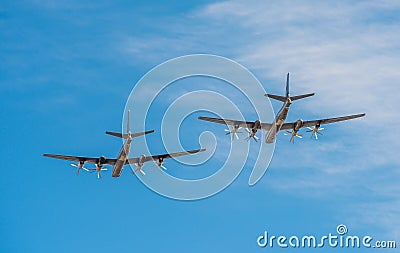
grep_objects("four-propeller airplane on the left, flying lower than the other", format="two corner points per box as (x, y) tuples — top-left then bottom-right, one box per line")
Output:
(43, 111), (205, 178)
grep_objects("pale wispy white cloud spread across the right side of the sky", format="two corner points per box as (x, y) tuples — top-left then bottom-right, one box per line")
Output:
(114, 0), (400, 234)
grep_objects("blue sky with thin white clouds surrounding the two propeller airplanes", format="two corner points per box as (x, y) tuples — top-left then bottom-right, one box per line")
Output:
(0, 0), (400, 252)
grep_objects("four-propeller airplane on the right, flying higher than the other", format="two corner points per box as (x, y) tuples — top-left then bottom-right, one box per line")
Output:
(198, 73), (365, 143)
